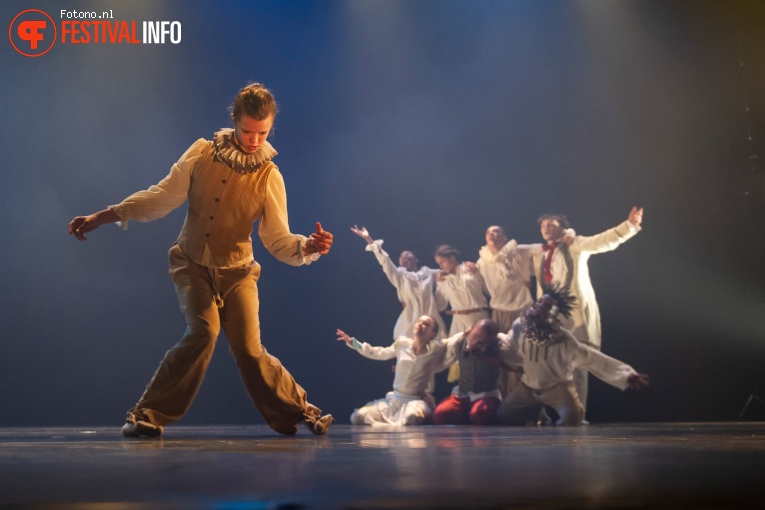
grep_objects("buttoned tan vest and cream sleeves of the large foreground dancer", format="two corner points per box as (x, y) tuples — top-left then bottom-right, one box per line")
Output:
(112, 138), (314, 268)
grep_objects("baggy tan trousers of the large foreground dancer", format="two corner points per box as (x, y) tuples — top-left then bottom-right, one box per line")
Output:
(129, 244), (310, 434)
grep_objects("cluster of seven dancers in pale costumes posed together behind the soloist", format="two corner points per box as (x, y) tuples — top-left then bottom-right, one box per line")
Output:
(344, 207), (648, 426)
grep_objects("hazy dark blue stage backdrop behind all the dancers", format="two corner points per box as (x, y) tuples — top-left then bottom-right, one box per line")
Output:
(0, 0), (765, 426)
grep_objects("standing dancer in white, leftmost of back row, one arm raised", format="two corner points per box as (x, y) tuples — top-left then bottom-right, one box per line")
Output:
(351, 225), (446, 340)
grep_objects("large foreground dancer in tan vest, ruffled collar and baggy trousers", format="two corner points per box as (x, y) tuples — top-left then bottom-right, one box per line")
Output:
(69, 83), (333, 437)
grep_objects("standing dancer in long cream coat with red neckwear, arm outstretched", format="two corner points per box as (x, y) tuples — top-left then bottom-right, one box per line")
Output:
(534, 207), (643, 410)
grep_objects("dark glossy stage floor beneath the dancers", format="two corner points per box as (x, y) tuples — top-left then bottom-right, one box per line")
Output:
(0, 422), (765, 510)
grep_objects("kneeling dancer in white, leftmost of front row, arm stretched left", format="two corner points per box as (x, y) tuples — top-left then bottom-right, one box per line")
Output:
(337, 315), (444, 426)
